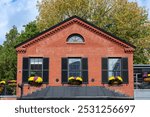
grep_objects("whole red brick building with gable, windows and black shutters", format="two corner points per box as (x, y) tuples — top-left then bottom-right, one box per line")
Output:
(16, 16), (135, 98)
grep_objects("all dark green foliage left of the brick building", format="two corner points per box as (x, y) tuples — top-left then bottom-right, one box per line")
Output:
(0, 21), (39, 80)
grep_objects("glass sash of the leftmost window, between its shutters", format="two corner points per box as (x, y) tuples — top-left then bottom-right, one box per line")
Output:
(29, 58), (43, 77)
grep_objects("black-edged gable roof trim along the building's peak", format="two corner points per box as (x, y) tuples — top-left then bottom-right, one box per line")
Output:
(15, 16), (136, 49)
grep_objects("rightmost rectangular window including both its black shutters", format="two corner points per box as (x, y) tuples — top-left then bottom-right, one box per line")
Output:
(102, 58), (128, 84)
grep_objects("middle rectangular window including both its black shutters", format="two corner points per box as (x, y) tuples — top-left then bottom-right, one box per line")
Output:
(61, 58), (88, 84)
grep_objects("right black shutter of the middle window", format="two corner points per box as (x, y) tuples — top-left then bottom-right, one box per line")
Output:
(82, 58), (88, 84)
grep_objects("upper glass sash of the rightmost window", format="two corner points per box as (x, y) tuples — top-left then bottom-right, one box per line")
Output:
(108, 59), (121, 71)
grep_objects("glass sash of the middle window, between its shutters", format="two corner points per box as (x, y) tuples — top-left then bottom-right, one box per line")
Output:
(68, 58), (81, 77)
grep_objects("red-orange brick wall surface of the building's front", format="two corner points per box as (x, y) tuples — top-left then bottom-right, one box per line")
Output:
(17, 20), (134, 96)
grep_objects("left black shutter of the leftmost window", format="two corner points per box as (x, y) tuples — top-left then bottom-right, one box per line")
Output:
(22, 58), (29, 83)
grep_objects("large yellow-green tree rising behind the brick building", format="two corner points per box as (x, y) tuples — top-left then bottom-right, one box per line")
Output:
(37, 0), (150, 63)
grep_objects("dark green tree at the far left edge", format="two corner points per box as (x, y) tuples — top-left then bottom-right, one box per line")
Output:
(0, 26), (19, 79)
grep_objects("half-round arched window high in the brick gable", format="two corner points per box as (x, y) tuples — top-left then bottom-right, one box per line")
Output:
(67, 34), (84, 43)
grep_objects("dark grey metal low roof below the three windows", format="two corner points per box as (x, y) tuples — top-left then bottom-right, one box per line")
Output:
(18, 86), (133, 100)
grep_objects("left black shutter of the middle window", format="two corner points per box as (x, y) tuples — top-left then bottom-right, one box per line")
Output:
(61, 58), (68, 83)
